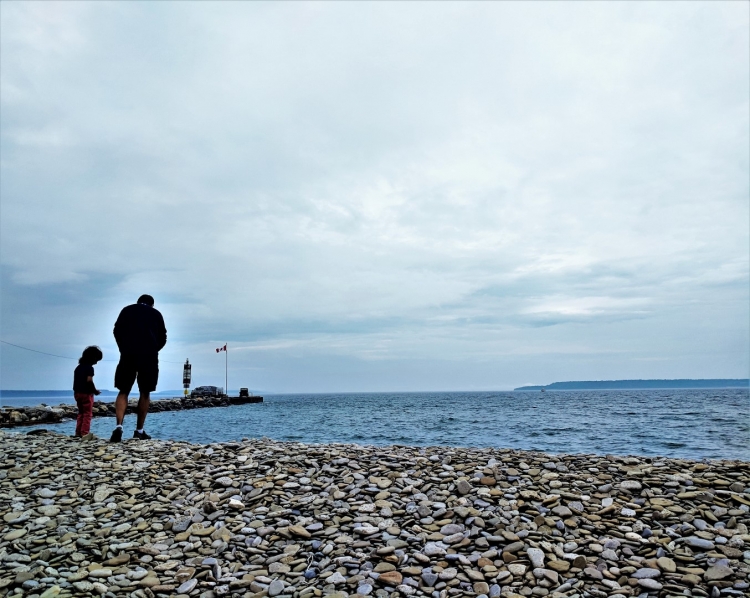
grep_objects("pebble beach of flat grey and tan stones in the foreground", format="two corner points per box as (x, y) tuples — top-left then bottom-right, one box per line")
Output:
(0, 431), (750, 598)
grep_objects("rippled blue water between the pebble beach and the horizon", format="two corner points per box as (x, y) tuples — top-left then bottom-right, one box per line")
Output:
(3, 389), (750, 461)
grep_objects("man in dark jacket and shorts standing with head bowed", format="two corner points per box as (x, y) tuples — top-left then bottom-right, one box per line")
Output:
(109, 295), (167, 442)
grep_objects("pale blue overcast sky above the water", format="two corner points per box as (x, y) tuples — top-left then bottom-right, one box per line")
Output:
(0, 0), (750, 393)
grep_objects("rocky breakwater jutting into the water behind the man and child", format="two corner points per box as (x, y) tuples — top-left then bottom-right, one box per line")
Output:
(0, 396), (263, 428)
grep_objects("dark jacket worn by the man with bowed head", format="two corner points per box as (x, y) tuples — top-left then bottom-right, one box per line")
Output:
(114, 303), (167, 355)
